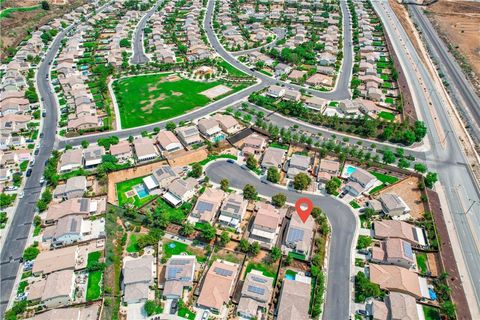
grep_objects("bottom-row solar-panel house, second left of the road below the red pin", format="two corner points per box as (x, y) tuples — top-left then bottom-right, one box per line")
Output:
(237, 270), (273, 319)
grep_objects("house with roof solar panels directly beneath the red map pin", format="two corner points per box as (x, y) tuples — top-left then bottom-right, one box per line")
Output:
(282, 213), (315, 259)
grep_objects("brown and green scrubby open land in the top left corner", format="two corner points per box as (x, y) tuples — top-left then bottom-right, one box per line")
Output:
(0, 0), (87, 59)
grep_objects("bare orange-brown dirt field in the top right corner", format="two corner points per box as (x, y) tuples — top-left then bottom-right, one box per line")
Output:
(427, 0), (480, 90)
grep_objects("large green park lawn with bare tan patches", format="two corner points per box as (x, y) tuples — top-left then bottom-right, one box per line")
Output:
(113, 74), (245, 129)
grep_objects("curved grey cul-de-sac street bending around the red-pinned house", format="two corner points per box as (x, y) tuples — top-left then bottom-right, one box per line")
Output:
(205, 161), (357, 320)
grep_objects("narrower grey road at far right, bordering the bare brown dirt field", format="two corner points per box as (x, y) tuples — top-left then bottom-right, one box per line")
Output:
(409, 6), (480, 140)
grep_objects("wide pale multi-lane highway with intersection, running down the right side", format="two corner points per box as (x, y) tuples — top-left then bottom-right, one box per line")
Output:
(372, 0), (480, 315)
